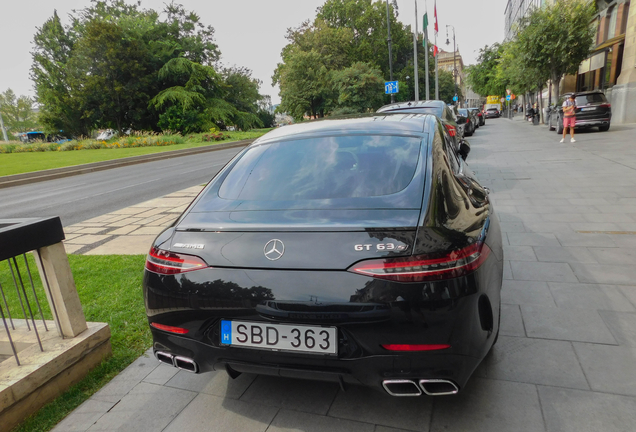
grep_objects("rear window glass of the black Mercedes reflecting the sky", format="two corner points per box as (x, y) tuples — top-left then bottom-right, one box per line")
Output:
(219, 135), (421, 201)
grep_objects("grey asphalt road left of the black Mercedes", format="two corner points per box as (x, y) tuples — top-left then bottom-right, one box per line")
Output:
(0, 148), (242, 226)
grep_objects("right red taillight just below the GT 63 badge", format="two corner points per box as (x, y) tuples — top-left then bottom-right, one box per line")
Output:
(348, 242), (490, 282)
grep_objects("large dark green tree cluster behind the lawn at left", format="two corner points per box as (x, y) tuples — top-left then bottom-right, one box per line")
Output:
(31, 0), (263, 135)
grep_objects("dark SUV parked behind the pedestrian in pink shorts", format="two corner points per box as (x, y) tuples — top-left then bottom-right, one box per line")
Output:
(548, 90), (612, 134)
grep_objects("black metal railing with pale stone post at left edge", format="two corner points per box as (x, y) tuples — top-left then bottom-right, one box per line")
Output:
(0, 217), (87, 365)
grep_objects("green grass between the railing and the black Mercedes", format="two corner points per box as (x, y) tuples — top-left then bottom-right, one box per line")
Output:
(0, 255), (152, 432)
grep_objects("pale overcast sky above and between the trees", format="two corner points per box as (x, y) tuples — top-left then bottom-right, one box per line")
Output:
(0, 0), (506, 103)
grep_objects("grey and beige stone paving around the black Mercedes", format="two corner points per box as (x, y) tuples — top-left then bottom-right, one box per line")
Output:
(54, 118), (636, 432)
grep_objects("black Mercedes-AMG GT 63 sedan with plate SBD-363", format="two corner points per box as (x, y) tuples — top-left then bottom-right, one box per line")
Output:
(143, 114), (503, 396)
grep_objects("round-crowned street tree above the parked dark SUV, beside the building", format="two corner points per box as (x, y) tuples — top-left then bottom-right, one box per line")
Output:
(516, 0), (596, 98)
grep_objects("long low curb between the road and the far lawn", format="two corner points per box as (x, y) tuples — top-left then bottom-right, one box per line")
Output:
(0, 139), (254, 189)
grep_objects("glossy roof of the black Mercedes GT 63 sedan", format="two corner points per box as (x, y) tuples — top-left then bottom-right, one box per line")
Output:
(254, 113), (436, 144)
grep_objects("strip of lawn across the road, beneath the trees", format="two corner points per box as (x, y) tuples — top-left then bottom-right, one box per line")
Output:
(0, 129), (271, 176)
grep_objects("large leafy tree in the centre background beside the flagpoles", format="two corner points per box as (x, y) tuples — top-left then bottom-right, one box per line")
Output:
(272, 0), (413, 120)
